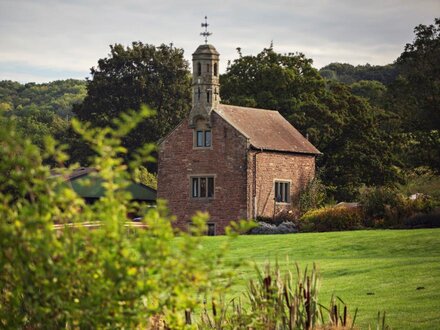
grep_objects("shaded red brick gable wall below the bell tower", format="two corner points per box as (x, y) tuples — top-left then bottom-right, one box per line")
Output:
(157, 113), (248, 234)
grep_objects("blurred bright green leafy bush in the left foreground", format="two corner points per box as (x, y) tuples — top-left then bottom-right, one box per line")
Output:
(0, 109), (248, 329)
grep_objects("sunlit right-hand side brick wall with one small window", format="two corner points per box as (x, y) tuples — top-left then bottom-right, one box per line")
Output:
(248, 151), (315, 218)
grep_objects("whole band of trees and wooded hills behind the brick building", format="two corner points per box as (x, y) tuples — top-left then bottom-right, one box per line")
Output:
(0, 19), (440, 200)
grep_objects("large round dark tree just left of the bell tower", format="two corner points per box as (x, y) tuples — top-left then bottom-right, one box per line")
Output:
(73, 42), (191, 165)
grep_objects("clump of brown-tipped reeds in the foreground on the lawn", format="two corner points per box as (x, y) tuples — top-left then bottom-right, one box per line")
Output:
(199, 264), (357, 329)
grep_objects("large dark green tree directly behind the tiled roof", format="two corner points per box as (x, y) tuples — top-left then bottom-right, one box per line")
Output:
(221, 49), (396, 199)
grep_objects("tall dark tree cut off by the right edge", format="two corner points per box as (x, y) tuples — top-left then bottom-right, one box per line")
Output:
(388, 18), (440, 173)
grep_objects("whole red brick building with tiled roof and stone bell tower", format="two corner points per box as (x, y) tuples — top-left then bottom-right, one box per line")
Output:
(157, 44), (319, 235)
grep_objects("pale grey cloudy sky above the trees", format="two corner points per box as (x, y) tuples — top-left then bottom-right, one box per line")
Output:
(0, 0), (440, 83)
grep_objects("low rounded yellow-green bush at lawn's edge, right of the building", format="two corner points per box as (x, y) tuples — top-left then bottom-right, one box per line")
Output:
(299, 206), (362, 232)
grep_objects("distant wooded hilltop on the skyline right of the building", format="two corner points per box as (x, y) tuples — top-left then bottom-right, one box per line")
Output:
(319, 63), (399, 85)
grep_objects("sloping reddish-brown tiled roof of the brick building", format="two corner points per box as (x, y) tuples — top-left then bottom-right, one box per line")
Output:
(214, 104), (320, 155)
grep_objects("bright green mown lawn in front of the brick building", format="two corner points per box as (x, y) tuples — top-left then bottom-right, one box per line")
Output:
(204, 229), (440, 329)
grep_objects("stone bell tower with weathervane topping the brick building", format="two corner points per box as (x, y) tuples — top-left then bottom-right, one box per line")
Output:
(189, 16), (220, 127)
